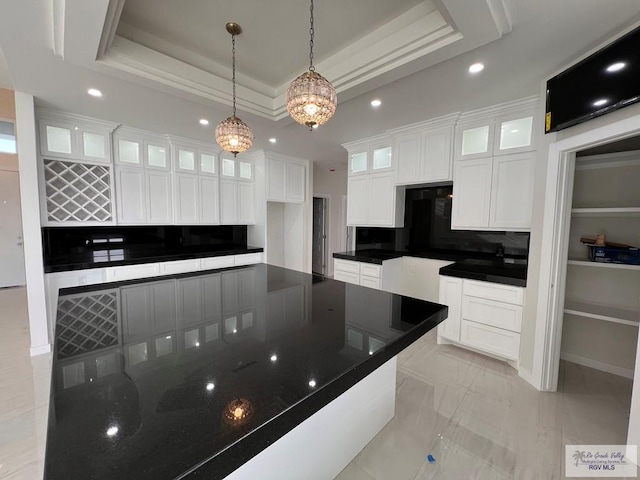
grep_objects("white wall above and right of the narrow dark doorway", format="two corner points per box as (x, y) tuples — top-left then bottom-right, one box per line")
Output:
(313, 162), (347, 276)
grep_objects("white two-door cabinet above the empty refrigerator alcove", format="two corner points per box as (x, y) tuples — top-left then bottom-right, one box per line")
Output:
(266, 153), (308, 203)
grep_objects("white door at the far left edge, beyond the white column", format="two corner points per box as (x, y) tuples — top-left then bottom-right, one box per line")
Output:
(0, 170), (26, 288)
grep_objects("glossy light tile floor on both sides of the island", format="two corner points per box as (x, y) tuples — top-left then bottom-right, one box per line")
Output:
(0, 289), (631, 480)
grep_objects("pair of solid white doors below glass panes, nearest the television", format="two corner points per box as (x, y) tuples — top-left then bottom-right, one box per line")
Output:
(451, 153), (535, 231)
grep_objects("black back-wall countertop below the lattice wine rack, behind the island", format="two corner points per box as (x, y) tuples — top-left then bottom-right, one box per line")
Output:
(44, 244), (264, 273)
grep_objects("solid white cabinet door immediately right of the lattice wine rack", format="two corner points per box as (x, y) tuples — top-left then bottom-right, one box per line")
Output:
(116, 167), (147, 224)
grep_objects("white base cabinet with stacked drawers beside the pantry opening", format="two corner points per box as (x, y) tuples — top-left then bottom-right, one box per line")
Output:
(438, 276), (525, 360)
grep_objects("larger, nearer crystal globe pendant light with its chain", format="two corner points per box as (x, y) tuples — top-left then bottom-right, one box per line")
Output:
(287, 0), (338, 131)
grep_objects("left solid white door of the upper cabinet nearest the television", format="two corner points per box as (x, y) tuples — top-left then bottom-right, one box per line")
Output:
(451, 157), (492, 230)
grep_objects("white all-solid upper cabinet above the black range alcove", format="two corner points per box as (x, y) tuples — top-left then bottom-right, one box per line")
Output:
(390, 113), (459, 185)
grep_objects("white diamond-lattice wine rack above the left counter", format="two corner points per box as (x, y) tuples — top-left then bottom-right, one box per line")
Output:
(44, 160), (113, 223)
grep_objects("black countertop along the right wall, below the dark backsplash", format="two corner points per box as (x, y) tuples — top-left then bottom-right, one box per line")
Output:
(333, 249), (527, 287)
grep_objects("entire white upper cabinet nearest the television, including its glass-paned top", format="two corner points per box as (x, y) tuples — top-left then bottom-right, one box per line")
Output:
(451, 97), (538, 231)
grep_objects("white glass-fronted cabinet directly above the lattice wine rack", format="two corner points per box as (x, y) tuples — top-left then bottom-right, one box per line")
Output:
(39, 111), (116, 163)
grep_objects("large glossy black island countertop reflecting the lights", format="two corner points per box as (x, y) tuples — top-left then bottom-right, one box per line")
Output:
(45, 264), (447, 480)
